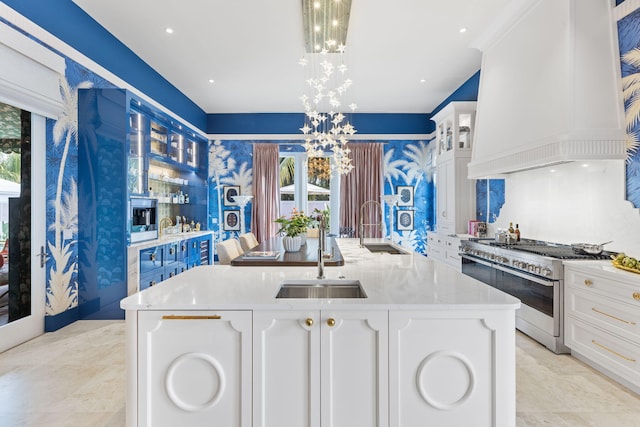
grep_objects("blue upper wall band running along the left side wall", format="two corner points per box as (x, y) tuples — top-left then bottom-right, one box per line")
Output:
(3, 0), (207, 131)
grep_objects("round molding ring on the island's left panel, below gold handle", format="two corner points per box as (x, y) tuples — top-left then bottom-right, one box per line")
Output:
(165, 353), (225, 412)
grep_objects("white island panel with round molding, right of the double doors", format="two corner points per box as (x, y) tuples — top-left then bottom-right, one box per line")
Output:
(389, 311), (515, 427)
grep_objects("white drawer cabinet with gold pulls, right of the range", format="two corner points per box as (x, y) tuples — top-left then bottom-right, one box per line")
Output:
(564, 261), (640, 393)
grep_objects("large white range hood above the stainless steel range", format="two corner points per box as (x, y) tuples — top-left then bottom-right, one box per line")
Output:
(469, 0), (626, 178)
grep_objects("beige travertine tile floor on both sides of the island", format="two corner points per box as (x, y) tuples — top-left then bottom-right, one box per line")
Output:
(0, 320), (640, 427)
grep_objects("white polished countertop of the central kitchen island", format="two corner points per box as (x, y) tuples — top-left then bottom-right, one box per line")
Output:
(120, 239), (520, 310)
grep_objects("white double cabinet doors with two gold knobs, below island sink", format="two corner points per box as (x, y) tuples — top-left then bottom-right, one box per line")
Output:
(253, 310), (388, 427)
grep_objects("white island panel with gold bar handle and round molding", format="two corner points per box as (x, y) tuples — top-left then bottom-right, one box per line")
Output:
(138, 311), (252, 427)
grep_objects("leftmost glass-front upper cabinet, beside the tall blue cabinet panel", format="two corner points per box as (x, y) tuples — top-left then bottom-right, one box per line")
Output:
(127, 110), (149, 194)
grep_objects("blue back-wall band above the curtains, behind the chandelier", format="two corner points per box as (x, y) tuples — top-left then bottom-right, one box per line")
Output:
(207, 113), (432, 135)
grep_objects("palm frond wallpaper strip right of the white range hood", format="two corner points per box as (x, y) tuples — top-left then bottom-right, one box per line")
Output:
(622, 48), (640, 163)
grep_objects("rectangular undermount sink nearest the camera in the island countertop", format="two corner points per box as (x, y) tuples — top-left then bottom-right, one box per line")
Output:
(276, 279), (367, 299)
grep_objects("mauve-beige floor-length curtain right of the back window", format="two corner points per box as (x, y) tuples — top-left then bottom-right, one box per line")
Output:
(340, 142), (384, 237)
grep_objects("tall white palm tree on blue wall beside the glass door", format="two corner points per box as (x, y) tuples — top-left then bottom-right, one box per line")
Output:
(46, 79), (92, 315)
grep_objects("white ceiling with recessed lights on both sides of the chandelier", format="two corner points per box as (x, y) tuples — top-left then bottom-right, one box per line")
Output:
(73, 0), (511, 113)
